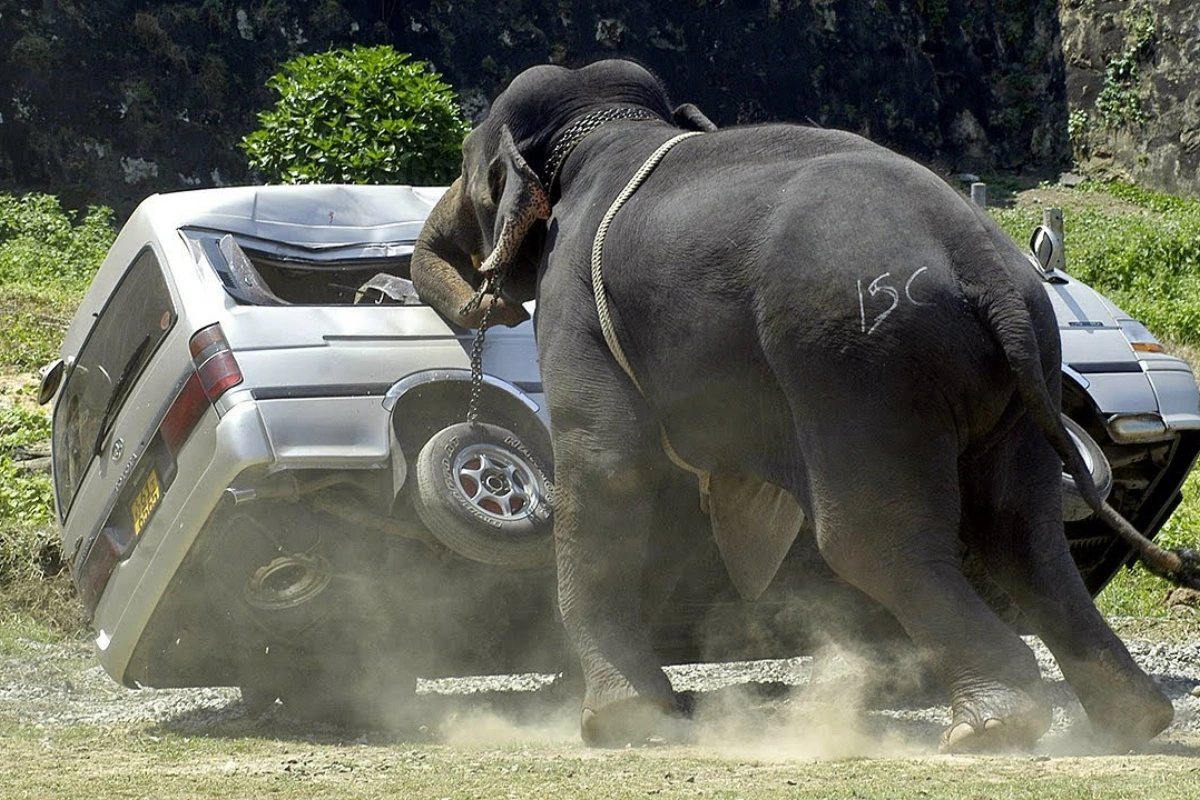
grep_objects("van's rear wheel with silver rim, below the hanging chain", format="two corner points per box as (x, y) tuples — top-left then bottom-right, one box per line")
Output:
(414, 422), (554, 569)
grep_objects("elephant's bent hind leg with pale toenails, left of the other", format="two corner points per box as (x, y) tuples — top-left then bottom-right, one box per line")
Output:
(805, 425), (1050, 752)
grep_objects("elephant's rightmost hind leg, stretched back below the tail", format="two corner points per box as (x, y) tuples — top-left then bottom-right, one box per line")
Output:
(966, 421), (1174, 750)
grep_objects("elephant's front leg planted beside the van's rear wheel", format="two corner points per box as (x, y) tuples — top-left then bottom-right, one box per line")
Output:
(554, 429), (679, 746)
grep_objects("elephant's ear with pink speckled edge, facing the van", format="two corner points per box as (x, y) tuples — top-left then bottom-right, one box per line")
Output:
(479, 126), (550, 273)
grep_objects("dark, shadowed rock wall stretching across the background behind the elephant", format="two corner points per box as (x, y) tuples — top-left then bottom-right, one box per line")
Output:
(0, 0), (1069, 213)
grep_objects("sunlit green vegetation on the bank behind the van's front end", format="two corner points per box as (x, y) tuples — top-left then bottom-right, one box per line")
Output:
(992, 182), (1200, 344)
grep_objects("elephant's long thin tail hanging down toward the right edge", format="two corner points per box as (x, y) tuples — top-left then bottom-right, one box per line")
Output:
(960, 230), (1200, 589)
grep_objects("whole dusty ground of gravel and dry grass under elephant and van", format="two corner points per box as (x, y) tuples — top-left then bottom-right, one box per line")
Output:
(0, 612), (1200, 800)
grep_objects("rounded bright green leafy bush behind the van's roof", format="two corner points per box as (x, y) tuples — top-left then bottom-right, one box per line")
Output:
(241, 46), (469, 185)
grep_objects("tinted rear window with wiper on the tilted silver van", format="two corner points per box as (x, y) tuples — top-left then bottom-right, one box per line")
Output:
(52, 249), (176, 515)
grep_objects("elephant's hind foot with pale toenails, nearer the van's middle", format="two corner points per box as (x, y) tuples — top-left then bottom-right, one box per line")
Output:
(938, 688), (1050, 753)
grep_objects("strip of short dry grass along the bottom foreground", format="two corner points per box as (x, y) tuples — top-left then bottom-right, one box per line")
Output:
(0, 723), (1200, 800)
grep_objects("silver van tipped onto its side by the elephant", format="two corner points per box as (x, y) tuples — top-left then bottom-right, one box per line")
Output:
(42, 186), (1200, 721)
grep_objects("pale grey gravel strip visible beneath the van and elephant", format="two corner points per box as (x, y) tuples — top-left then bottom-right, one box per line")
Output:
(0, 638), (1200, 752)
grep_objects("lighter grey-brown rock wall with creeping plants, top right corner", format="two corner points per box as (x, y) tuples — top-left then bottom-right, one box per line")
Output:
(1062, 0), (1200, 196)
